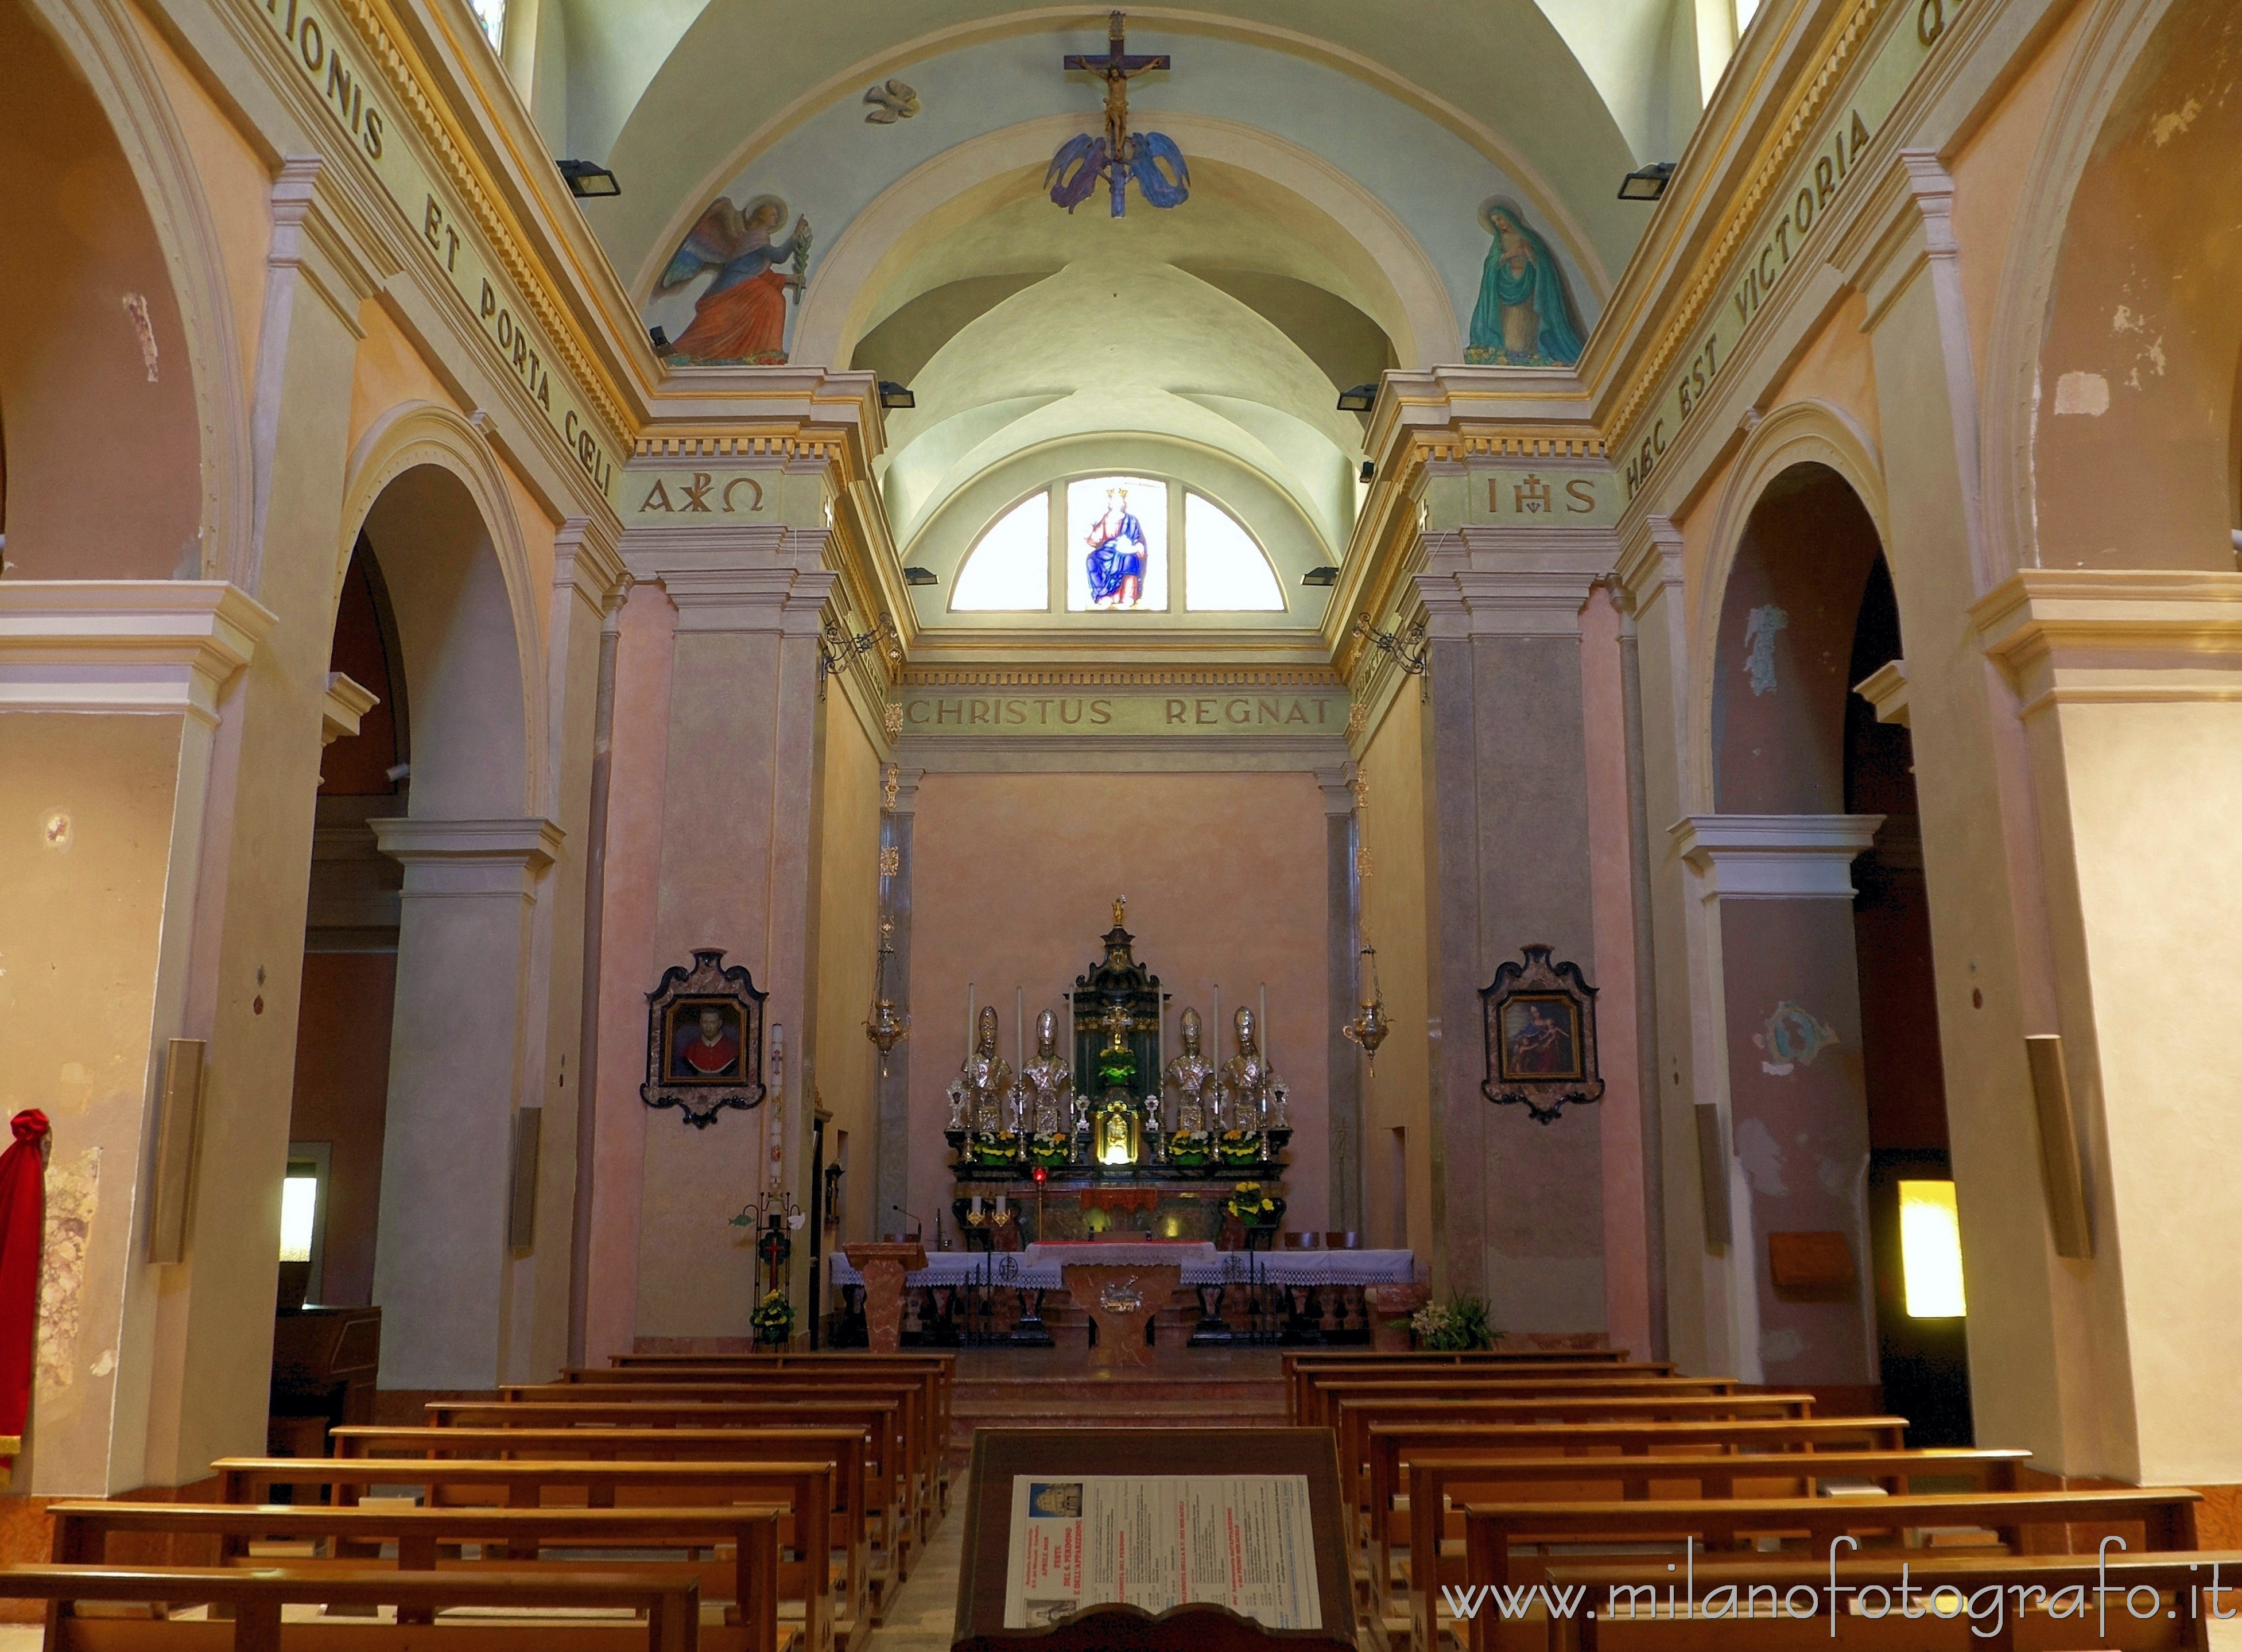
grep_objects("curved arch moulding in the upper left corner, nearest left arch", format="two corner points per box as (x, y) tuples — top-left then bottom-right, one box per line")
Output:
(7, 0), (255, 590)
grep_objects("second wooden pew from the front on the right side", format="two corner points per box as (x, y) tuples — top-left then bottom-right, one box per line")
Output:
(1464, 1488), (2202, 1652)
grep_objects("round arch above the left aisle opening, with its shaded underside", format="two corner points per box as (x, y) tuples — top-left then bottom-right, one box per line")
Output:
(332, 401), (549, 816)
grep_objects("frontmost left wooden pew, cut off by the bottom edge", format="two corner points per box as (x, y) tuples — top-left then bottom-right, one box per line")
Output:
(0, 1565), (700, 1652)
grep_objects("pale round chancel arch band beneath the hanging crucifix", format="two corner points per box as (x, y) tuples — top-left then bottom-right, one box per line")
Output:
(794, 112), (1462, 366)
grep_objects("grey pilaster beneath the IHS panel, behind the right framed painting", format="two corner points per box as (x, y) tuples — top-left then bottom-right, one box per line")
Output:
(1417, 509), (1616, 1333)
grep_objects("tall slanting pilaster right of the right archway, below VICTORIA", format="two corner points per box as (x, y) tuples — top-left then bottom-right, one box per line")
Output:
(1832, 154), (2080, 1475)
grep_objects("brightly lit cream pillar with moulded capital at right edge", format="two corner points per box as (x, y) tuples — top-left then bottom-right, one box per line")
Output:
(1981, 567), (2242, 1486)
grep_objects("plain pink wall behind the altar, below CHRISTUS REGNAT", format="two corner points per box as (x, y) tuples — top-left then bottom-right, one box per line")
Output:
(910, 773), (1329, 1231)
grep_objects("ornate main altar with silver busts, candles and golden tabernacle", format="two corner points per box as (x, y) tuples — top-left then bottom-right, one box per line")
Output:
(944, 899), (1291, 1251)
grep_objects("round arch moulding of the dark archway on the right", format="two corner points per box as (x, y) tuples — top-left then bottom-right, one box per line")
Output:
(1684, 399), (1896, 814)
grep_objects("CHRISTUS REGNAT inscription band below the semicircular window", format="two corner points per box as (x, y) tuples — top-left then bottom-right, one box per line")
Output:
(899, 688), (1348, 740)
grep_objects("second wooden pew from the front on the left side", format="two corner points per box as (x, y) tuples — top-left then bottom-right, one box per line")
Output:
(47, 1502), (794, 1652)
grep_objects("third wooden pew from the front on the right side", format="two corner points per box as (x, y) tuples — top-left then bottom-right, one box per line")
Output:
(1370, 1448), (2031, 1647)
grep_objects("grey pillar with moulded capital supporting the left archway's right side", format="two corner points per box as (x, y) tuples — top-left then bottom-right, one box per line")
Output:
(368, 818), (563, 1387)
